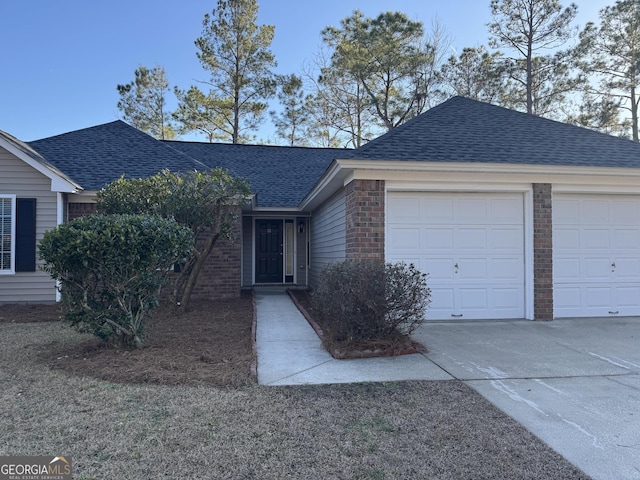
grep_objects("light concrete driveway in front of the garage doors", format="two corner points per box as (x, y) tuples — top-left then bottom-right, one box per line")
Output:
(414, 318), (640, 480)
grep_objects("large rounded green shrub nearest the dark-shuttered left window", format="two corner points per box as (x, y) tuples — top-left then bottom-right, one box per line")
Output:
(39, 215), (193, 348)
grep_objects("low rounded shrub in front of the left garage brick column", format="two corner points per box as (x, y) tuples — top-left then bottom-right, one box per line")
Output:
(313, 260), (430, 342)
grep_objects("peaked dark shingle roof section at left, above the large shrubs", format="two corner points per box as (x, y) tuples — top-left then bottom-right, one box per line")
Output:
(29, 120), (203, 190)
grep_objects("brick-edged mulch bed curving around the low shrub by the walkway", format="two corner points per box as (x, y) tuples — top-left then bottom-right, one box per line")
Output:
(288, 289), (427, 360)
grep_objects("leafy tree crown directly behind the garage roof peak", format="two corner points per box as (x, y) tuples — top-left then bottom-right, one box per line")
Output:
(442, 46), (509, 106)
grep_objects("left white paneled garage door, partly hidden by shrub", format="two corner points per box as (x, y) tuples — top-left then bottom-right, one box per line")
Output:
(386, 192), (525, 320)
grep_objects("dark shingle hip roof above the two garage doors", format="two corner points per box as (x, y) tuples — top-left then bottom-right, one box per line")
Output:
(351, 97), (640, 168)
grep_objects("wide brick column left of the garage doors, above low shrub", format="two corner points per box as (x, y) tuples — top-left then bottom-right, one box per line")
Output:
(346, 180), (384, 260)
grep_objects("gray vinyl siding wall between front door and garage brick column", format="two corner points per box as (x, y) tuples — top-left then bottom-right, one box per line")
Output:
(309, 190), (346, 287)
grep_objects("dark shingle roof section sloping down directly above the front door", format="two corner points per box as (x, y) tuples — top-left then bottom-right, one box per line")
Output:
(165, 141), (351, 207)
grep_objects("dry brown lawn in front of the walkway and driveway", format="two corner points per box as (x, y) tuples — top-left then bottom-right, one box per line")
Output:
(0, 298), (587, 480)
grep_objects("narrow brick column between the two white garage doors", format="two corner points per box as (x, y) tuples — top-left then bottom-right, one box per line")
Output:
(533, 183), (553, 320)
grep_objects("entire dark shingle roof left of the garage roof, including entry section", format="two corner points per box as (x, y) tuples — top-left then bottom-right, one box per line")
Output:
(29, 120), (348, 207)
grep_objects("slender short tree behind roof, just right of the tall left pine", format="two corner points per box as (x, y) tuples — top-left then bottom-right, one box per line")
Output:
(269, 75), (309, 147)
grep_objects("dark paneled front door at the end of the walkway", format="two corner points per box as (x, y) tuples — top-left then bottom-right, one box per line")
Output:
(256, 220), (283, 283)
